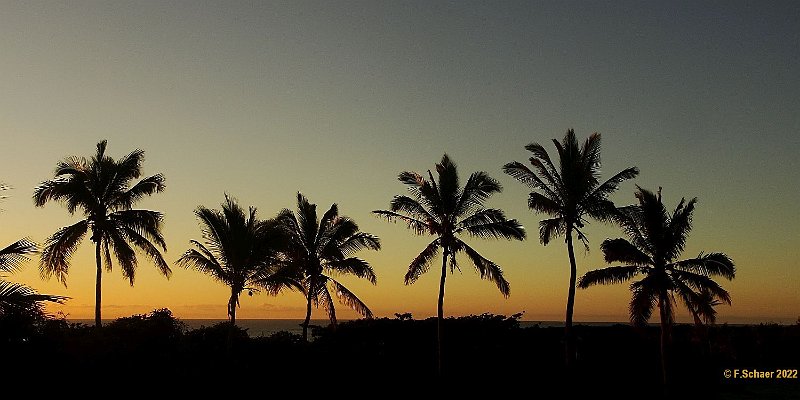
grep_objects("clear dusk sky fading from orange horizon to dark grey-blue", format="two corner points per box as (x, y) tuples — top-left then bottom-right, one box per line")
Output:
(0, 1), (800, 323)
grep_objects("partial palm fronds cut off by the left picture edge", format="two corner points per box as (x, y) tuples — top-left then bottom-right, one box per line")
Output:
(0, 239), (67, 317)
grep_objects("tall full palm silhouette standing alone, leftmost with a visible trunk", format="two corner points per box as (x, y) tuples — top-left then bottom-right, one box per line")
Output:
(33, 140), (172, 328)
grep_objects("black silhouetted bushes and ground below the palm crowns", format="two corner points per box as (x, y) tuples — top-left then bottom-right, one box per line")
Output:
(0, 310), (800, 399)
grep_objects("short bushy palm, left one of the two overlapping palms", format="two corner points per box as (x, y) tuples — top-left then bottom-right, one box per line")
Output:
(178, 195), (299, 325)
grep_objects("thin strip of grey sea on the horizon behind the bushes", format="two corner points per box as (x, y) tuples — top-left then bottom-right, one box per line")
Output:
(69, 319), (627, 337)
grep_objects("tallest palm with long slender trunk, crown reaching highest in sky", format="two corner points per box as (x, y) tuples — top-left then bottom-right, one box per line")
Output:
(503, 129), (639, 366)
